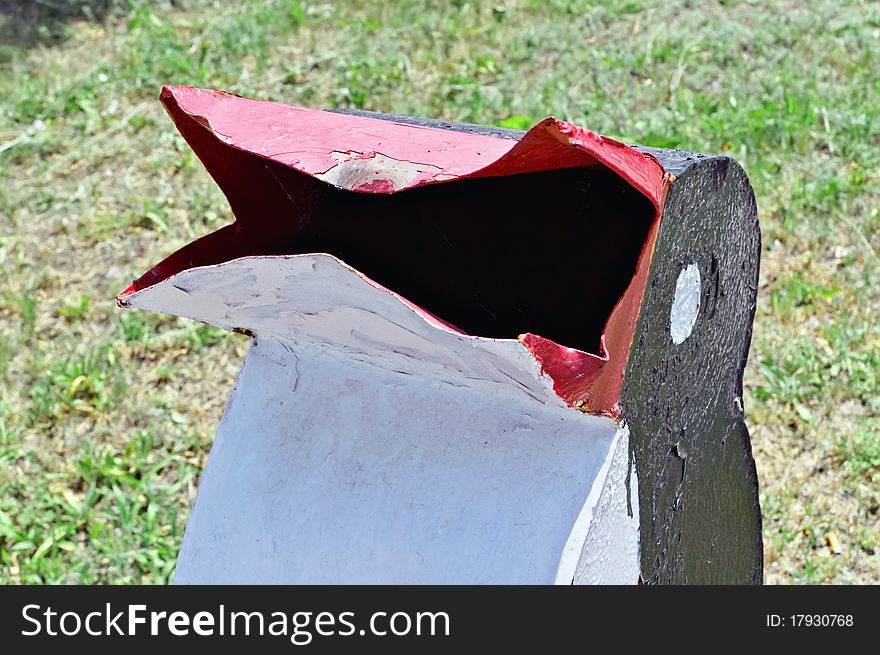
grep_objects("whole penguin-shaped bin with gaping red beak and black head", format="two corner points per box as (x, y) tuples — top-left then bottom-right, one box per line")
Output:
(117, 87), (762, 585)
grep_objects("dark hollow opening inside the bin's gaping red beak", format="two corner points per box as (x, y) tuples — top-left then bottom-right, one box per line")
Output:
(135, 151), (654, 352)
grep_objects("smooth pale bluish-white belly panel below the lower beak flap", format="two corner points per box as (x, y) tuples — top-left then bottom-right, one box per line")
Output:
(175, 340), (624, 584)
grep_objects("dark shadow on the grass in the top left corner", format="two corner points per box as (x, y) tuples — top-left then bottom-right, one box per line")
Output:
(0, 0), (117, 48)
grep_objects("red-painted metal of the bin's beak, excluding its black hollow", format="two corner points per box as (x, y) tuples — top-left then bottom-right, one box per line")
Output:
(119, 87), (669, 416)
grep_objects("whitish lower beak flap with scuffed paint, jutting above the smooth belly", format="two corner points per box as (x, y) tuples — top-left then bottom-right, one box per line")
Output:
(125, 254), (573, 404)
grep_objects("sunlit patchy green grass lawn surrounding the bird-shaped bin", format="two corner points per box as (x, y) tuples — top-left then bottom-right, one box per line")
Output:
(0, 0), (880, 583)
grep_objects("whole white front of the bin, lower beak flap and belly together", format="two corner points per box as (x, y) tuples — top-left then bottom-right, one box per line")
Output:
(127, 255), (638, 584)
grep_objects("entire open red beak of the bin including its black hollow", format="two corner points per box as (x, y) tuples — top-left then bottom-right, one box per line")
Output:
(119, 87), (667, 416)
